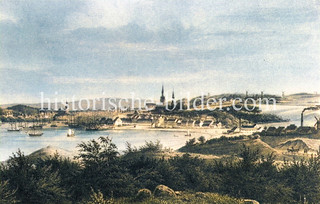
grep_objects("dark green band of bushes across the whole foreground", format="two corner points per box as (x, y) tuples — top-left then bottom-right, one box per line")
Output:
(0, 137), (320, 204)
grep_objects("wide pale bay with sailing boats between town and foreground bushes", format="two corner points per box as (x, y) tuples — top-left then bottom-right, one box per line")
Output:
(0, 124), (222, 161)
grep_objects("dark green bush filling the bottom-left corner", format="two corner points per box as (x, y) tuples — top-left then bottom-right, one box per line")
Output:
(1, 150), (66, 204)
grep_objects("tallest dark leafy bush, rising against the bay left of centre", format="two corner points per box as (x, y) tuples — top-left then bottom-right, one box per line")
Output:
(76, 137), (135, 197)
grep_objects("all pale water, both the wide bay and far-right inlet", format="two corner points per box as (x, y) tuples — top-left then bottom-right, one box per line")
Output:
(0, 105), (320, 161)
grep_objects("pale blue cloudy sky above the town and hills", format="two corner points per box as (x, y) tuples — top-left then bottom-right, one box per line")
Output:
(0, 0), (320, 104)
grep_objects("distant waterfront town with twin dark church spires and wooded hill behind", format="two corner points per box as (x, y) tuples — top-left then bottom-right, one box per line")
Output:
(1, 86), (281, 133)
